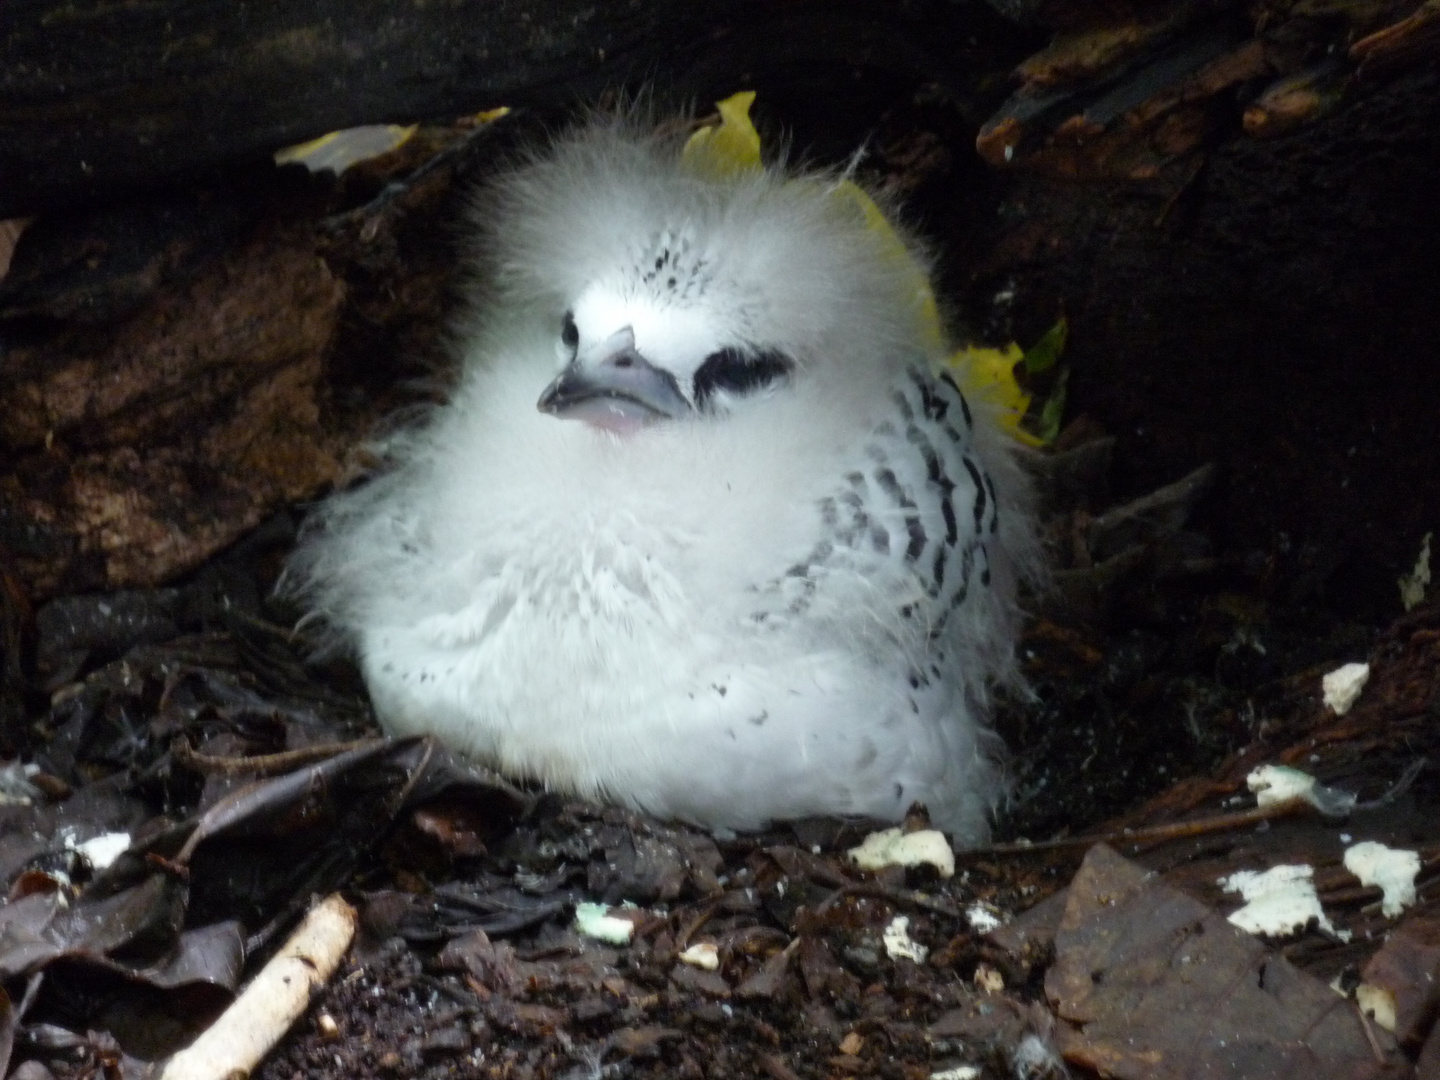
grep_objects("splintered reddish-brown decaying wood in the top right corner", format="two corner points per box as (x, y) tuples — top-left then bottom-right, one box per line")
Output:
(976, 0), (1440, 181)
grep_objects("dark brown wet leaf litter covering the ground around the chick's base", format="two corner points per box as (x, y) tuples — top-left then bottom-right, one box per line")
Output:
(0, 498), (1440, 1080)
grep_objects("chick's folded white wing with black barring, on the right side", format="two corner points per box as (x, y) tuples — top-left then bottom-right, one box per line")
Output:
(717, 367), (1011, 842)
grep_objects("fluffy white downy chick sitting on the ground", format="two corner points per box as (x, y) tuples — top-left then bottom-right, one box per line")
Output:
(289, 108), (1032, 844)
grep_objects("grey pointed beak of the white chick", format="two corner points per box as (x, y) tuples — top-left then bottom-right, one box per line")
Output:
(537, 327), (690, 431)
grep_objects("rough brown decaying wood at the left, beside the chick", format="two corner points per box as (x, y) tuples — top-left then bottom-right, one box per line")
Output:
(0, 218), (346, 595)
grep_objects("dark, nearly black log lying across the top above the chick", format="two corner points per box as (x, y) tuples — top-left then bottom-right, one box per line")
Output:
(0, 0), (1022, 217)
